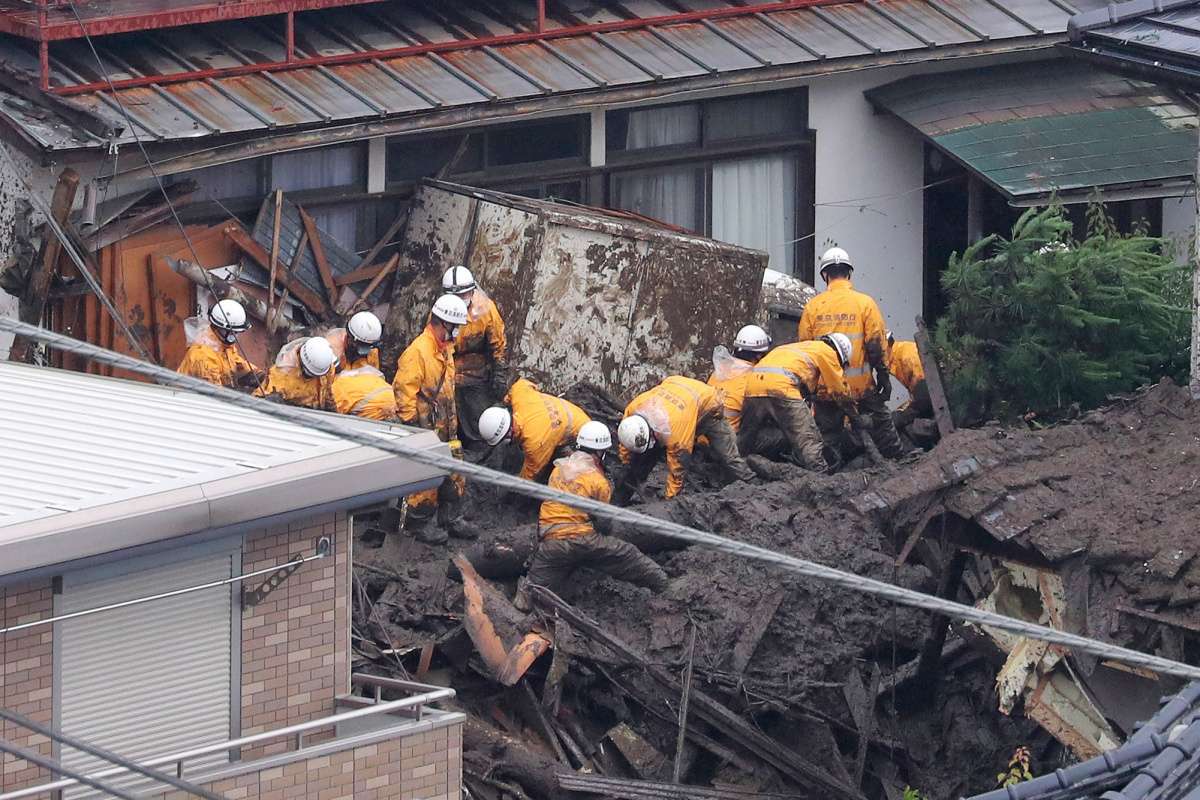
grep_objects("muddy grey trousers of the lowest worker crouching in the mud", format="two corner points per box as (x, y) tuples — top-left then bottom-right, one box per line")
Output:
(526, 533), (667, 594)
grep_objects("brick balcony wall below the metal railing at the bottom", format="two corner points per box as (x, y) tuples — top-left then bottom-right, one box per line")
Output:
(157, 722), (462, 800)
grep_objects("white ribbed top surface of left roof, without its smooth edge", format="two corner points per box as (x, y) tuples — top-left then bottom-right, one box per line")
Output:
(0, 361), (422, 527)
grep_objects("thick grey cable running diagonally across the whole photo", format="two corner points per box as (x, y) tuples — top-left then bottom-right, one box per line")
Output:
(7, 318), (1200, 680)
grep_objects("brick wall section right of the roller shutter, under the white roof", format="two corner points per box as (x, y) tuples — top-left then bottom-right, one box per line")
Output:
(241, 512), (350, 743)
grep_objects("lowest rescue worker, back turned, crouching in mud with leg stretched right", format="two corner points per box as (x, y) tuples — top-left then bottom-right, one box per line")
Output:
(514, 421), (667, 610)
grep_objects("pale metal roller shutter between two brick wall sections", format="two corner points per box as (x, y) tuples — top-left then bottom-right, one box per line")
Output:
(58, 542), (240, 798)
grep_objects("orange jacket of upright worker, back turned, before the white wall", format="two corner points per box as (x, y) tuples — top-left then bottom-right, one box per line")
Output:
(798, 278), (888, 399)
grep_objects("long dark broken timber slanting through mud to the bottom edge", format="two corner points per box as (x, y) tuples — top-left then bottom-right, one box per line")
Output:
(529, 587), (864, 800)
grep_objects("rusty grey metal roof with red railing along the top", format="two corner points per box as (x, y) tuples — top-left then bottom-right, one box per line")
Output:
(0, 0), (1096, 149)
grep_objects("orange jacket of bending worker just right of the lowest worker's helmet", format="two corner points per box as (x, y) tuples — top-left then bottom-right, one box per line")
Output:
(620, 375), (724, 498)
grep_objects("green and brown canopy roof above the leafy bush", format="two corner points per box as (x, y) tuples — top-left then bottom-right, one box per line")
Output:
(868, 61), (1198, 198)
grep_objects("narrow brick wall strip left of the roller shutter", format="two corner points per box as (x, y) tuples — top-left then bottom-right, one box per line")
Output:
(0, 581), (54, 792)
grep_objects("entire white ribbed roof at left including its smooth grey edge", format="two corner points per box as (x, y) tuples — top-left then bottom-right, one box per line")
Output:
(0, 361), (444, 577)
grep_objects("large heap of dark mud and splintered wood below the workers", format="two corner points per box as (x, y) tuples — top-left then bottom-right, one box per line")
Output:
(354, 384), (1200, 800)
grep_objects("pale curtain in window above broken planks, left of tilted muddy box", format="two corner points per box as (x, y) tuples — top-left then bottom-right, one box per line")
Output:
(271, 145), (365, 249)
